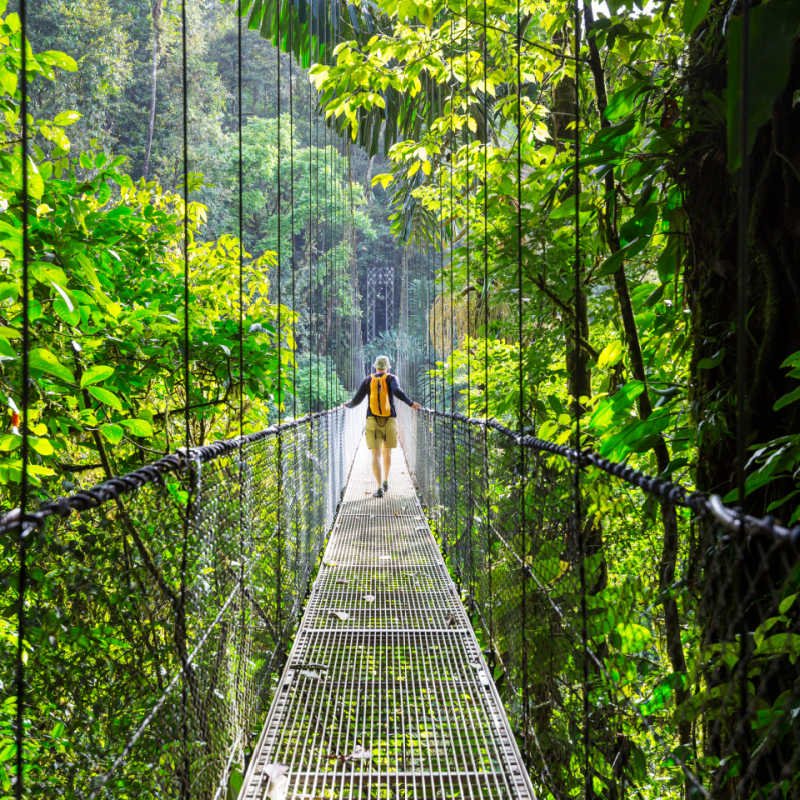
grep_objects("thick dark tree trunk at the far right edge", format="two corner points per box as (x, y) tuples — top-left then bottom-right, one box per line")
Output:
(678, 0), (800, 798)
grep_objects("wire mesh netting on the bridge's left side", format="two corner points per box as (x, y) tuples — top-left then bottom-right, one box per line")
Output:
(0, 411), (357, 799)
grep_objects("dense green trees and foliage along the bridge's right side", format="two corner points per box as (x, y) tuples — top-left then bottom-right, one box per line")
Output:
(296, 0), (800, 796)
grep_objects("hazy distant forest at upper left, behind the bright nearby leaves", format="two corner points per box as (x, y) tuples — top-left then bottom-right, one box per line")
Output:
(23, 0), (418, 408)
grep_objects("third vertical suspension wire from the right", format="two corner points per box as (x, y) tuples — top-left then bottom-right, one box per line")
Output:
(514, 0), (529, 749)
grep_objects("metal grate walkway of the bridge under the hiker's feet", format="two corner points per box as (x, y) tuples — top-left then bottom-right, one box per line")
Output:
(240, 446), (533, 800)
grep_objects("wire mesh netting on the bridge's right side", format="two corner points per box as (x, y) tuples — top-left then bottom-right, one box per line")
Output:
(403, 414), (800, 798)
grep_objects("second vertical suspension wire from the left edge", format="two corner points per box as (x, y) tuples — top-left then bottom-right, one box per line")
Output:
(178, 0), (194, 800)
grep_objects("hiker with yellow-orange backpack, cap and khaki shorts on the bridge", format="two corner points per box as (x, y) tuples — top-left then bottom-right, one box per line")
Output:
(342, 356), (422, 497)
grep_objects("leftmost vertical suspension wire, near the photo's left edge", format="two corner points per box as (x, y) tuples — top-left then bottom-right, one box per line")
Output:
(14, 0), (31, 800)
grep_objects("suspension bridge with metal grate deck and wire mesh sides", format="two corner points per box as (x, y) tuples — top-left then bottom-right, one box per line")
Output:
(2, 400), (798, 800)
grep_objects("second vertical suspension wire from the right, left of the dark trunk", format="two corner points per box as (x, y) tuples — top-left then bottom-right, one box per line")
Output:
(572, 0), (594, 798)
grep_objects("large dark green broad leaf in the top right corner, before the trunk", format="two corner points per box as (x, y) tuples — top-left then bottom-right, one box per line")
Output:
(727, 0), (800, 172)
